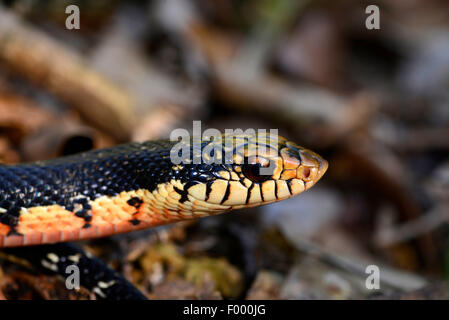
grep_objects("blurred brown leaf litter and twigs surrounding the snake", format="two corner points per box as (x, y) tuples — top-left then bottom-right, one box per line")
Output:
(0, 0), (449, 299)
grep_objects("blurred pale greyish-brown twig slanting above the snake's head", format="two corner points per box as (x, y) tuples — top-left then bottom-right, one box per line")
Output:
(186, 24), (377, 146)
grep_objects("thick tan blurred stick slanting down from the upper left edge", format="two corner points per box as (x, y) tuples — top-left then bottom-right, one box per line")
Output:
(0, 6), (134, 140)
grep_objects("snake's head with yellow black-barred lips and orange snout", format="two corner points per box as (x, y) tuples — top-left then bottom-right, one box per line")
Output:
(172, 134), (328, 213)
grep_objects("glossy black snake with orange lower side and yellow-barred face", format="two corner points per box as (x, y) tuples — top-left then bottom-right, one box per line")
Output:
(0, 133), (328, 297)
